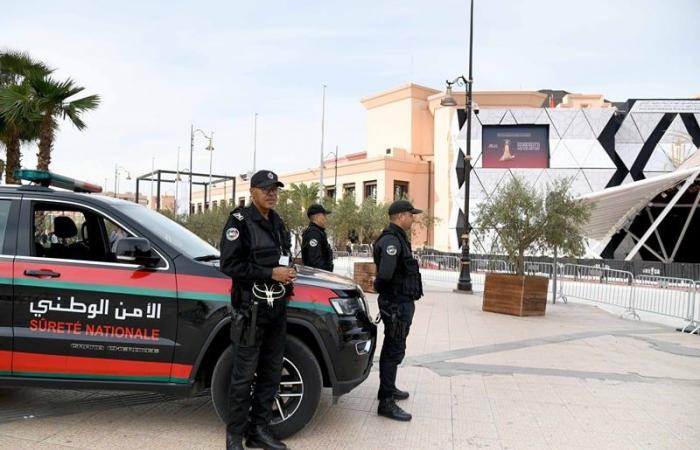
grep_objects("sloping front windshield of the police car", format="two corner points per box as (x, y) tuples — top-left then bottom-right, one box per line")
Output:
(119, 205), (219, 260)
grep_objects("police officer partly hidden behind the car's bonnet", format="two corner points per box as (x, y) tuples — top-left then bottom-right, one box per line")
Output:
(301, 204), (333, 272)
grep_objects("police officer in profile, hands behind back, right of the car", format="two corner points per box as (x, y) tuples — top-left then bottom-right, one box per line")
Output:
(374, 200), (423, 422)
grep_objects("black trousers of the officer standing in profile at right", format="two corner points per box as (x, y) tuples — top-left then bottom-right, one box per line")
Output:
(378, 296), (416, 400)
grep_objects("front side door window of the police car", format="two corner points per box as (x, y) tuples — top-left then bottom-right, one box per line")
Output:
(32, 203), (129, 262)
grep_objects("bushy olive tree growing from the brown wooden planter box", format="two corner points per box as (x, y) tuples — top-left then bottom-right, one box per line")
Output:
(474, 177), (590, 275)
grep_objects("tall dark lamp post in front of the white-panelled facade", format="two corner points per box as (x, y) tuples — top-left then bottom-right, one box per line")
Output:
(440, 0), (474, 293)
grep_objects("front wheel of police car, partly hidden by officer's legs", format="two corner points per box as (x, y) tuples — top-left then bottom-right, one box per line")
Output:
(211, 336), (323, 439)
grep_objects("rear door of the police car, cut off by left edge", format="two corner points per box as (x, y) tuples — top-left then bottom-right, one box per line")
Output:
(0, 196), (20, 376)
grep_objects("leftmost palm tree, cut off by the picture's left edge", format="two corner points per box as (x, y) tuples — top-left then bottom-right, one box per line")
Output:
(0, 52), (52, 183)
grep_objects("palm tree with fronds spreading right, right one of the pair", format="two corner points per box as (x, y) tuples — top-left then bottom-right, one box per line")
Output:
(29, 76), (100, 170)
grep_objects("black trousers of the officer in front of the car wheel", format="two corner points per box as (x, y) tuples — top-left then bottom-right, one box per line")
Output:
(227, 300), (287, 434)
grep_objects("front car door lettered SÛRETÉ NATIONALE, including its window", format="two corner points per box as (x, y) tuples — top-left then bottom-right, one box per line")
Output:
(12, 196), (182, 383)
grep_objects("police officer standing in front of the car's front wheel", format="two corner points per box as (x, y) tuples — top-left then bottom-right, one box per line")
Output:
(221, 170), (296, 450)
